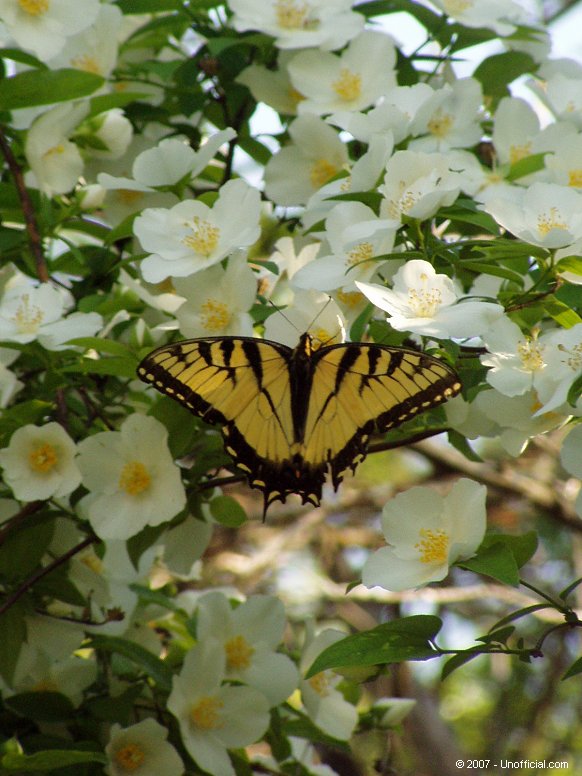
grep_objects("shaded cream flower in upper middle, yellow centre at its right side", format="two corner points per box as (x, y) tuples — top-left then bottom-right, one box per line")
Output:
(265, 116), (348, 205)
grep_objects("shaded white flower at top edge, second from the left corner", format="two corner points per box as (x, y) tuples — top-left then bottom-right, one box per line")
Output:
(50, 5), (123, 78)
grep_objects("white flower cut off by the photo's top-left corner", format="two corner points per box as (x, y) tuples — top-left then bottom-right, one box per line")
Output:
(0, 0), (99, 60)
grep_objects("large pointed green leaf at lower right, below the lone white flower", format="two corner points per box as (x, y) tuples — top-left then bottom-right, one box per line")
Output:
(306, 614), (442, 679)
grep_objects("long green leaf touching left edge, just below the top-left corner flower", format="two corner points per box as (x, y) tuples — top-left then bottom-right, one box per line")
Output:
(0, 68), (105, 110)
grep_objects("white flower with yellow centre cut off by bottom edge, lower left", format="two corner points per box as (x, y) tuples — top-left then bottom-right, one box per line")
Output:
(105, 718), (184, 776)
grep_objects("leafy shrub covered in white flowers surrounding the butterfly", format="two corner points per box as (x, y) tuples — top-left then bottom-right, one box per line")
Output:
(0, 0), (582, 776)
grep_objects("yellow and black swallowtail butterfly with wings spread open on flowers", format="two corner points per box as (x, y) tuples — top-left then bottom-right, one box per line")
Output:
(137, 333), (461, 516)
